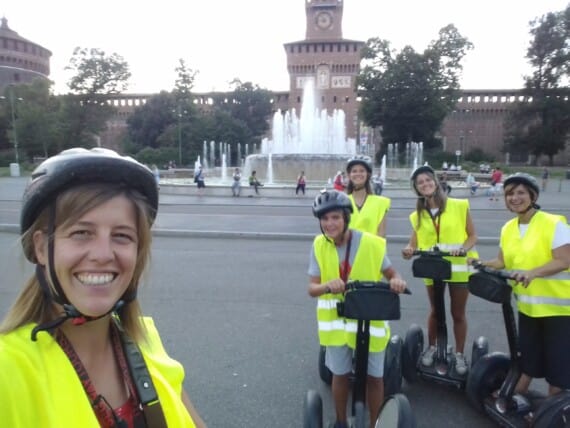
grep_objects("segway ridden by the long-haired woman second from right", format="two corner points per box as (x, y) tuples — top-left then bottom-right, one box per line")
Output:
(402, 247), (489, 389)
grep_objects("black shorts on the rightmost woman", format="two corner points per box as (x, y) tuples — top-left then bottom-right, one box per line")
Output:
(519, 312), (570, 389)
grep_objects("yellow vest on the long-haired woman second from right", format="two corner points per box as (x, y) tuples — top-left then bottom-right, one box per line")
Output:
(410, 198), (479, 285)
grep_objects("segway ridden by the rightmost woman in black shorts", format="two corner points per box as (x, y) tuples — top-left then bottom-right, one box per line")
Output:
(466, 261), (570, 428)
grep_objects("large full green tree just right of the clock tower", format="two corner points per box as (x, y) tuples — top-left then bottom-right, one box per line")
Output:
(357, 25), (473, 150)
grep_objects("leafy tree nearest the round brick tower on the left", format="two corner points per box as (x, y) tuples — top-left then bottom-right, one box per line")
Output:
(60, 47), (131, 148)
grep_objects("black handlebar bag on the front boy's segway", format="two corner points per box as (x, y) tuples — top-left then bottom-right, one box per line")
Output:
(337, 287), (400, 321)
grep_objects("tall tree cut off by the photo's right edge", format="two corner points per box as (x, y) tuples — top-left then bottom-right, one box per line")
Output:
(504, 5), (570, 165)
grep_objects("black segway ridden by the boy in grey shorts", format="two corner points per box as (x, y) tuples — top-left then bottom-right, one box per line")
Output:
(303, 281), (416, 428)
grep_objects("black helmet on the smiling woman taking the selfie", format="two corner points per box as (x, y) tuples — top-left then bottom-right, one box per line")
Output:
(20, 148), (158, 233)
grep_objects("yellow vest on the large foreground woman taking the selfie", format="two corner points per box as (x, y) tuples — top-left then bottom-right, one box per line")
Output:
(0, 318), (195, 428)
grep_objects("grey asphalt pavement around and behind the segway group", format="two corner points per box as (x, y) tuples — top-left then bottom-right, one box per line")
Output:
(0, 179), (570, 428)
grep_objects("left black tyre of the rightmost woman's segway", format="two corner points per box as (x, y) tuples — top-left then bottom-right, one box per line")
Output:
(466, 352), (511, 413)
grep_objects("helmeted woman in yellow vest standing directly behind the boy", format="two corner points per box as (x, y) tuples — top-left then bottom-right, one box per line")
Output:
(346, 155), (391, 237)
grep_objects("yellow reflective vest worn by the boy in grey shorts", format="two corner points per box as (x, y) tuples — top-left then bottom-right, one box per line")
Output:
(313, 232), (390, 352)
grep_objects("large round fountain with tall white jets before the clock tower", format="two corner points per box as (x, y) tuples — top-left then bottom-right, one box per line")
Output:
(244, 79), (356, 184)
